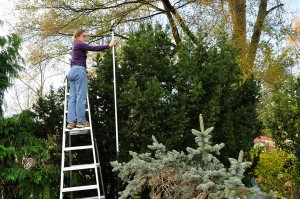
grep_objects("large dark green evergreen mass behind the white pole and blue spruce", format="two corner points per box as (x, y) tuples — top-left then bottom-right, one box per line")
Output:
(89, 24), (261, 197)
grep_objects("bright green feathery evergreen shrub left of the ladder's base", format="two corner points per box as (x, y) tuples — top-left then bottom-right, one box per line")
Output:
(0, 111), (60, 199)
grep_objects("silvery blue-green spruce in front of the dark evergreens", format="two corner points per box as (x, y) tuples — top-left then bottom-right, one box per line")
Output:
(111, 115), (275, 199)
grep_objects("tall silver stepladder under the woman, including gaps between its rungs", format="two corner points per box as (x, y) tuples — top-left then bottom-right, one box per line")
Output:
(59, 78), (105, 199)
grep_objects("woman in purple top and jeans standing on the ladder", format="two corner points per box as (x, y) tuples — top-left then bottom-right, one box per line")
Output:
(67, 29), (116, 129)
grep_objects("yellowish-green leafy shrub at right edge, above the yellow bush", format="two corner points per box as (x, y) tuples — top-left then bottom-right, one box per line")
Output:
(265, 77), (300, 188)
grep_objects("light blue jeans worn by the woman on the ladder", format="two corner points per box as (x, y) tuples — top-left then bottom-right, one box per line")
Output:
(67, 65), (87, 122)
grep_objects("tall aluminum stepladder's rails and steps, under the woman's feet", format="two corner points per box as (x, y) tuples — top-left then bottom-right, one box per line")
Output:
(60, 78), (105, 199)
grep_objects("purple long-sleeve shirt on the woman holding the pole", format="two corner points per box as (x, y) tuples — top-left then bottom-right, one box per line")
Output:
(71, 41), (109, 67)
